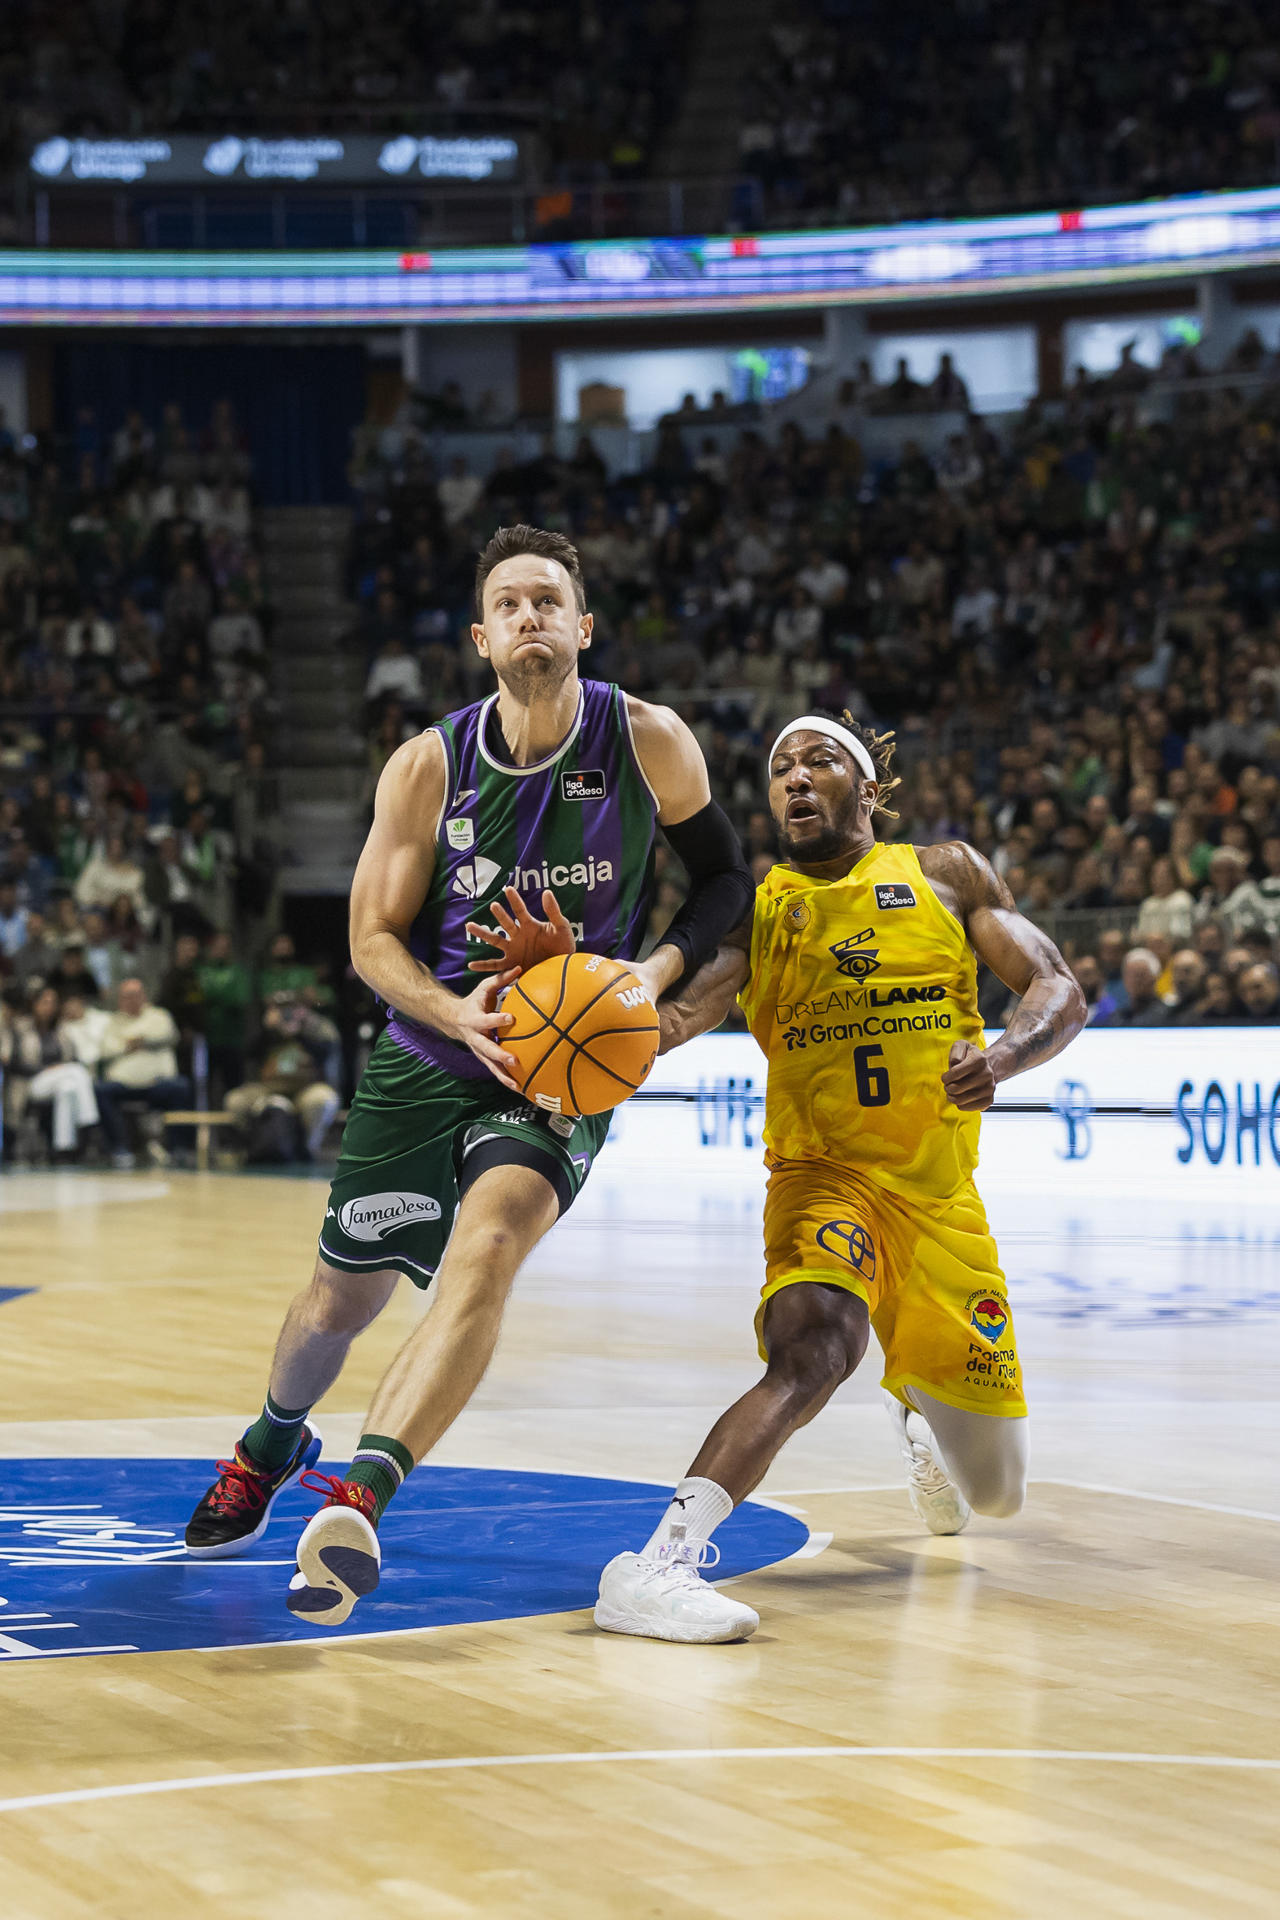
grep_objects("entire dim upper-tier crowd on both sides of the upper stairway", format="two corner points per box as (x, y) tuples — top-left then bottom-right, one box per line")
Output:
(0, 0), (1280, 238)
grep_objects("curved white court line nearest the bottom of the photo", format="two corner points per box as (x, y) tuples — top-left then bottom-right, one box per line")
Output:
(0, 1747), (1280, 1812)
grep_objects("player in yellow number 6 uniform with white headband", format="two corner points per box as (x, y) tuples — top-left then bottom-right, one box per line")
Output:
(595, 714), (1086, 1642)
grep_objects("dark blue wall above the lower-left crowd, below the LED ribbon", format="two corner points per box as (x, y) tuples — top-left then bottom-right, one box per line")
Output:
(54, 340), (365, 507)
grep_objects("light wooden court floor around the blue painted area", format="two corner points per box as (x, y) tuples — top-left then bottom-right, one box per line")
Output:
(0, 1175), (1280, 1920)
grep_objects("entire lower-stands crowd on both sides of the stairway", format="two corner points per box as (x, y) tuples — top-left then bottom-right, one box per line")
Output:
(14, 334), (1280, 1165)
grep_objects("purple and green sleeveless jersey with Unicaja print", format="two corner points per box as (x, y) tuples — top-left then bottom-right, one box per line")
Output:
(388, 680), (658, 1079)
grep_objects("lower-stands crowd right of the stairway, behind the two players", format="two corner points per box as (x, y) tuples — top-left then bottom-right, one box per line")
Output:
(349, 351), (1280, 1025)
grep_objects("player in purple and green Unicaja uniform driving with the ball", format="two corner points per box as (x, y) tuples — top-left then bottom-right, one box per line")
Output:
(186, 526), (752, 1626)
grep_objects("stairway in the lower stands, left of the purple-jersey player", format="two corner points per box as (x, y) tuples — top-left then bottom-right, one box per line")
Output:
(263, 507), (367, 895)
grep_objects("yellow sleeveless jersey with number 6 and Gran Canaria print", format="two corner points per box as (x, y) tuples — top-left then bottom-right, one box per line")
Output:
(739, 845), (983, 1198)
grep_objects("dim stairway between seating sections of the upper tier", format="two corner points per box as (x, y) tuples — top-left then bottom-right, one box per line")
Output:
(656, 0), (775, 180)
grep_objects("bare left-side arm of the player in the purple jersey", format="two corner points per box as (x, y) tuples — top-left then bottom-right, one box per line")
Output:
(351, 733), (514, 1089)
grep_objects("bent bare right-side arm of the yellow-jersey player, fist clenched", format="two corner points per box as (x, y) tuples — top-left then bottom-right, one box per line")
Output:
(919, 841), (1088, 1112)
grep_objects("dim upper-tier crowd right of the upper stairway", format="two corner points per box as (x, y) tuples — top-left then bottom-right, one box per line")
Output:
(739, 0), (1280, 227)
